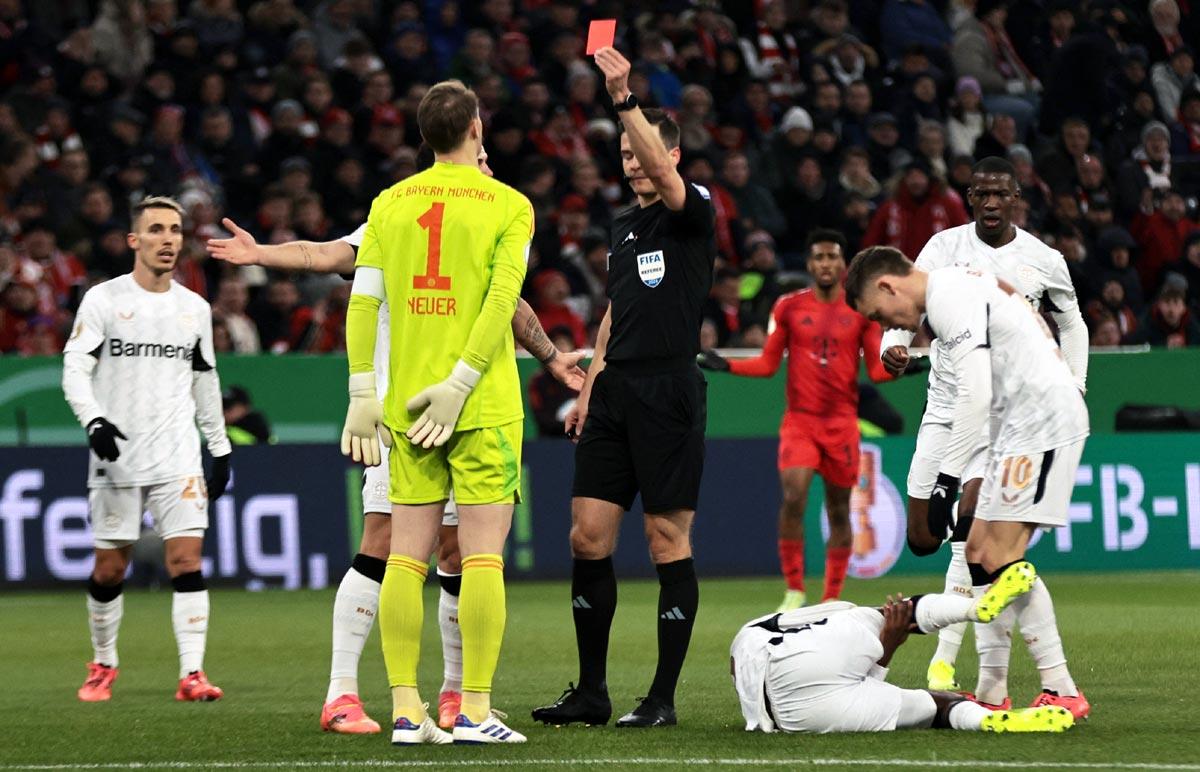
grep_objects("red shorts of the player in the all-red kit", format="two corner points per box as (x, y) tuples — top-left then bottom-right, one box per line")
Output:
(779, 412), (859, 487)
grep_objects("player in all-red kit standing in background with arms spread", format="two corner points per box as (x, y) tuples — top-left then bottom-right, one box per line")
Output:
(700, 229), (892, 611)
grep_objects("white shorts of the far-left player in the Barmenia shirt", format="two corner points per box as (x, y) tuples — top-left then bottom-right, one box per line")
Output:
(88, 475), (209, 550)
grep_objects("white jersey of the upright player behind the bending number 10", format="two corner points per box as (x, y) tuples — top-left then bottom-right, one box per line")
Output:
(880, 222), (1087, 425)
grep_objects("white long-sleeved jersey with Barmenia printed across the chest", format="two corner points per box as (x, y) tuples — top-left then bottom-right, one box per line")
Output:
(64, 274), (230, 487)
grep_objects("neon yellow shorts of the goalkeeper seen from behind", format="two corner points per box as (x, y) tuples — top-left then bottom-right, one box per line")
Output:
(388, 420), (524, 505)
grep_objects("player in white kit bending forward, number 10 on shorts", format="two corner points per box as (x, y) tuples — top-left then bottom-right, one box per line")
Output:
(846, 247), (1091, 718)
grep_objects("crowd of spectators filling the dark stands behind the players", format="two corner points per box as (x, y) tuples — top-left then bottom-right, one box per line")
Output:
(0, 0), (1200, 354)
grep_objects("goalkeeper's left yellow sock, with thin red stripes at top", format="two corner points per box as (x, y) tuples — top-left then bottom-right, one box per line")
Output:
(379, 555), (429, 723)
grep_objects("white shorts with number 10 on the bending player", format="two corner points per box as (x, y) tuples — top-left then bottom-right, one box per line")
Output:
(976, 439), (1086, 528)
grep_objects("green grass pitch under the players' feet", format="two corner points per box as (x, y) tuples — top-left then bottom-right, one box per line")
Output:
(0, 571), (1200, 772)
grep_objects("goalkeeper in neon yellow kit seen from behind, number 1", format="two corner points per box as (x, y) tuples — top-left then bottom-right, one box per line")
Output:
(342, 80), (533, 744)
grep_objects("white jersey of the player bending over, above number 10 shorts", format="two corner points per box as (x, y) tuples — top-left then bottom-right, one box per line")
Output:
(925, 268), (1088, 457)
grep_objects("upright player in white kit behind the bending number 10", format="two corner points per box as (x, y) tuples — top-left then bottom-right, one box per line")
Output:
(880, 156), (1088, 705)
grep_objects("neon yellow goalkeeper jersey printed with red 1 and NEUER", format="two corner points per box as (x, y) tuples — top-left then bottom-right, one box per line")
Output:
(350, 163), (534, 431)
